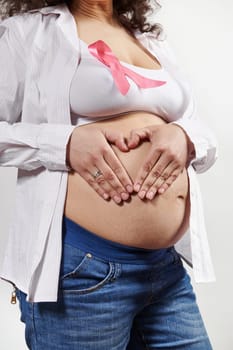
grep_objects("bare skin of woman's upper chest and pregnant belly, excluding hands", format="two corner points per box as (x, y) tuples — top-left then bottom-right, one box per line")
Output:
(64, 15), (190, 249)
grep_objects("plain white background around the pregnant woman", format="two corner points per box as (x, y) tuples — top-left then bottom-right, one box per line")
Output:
(0, 0), (233, 350)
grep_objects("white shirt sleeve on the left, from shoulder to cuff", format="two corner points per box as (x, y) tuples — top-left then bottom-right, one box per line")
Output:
(0, 18), (75, 171)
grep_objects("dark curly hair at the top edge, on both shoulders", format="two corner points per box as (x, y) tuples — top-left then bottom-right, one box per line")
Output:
(0, 0), (162, 35)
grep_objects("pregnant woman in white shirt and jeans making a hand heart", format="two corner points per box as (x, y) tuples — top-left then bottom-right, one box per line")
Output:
(0, 0), (216, 350)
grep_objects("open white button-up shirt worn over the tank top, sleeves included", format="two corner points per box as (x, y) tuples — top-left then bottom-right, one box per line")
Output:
(0, 4), (216, 302)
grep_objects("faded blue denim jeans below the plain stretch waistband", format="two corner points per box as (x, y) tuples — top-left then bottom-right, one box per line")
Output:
(17, 230), (212, 350)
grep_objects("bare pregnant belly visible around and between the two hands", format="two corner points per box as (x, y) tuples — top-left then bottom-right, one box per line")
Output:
(64, 112), (190, 249)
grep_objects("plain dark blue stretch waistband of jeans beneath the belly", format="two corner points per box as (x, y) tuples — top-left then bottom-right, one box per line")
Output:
(62, 216), (173, 264)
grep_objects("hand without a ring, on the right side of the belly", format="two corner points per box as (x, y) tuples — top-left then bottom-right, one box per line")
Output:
(128, 123), (195, 200)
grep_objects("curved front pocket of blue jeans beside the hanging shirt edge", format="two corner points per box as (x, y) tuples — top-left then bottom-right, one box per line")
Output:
(59, 244), (119, 294)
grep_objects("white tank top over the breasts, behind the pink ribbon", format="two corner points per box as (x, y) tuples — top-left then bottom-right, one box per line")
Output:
(70, 39), (187, 125)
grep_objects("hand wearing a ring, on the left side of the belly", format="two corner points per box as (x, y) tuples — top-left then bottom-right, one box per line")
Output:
(67, 127), (133, 204)
